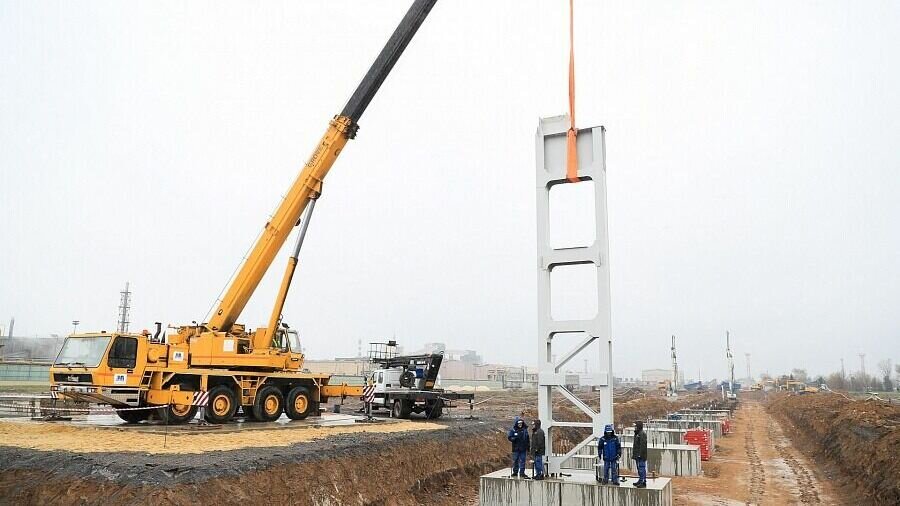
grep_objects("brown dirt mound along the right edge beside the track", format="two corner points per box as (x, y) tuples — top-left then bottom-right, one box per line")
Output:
(768, 393), (900, 504)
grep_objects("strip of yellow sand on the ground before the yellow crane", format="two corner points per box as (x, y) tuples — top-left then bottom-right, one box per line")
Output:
(0, 421), (445, 454)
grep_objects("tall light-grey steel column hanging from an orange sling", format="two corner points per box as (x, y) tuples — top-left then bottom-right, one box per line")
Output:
(536, 116), (613, 474)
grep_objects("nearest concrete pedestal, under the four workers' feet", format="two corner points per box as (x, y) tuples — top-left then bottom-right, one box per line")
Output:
(478, 468), (672, 506)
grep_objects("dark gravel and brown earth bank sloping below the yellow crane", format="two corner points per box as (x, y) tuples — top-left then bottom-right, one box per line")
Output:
(0, 422), (509, 506)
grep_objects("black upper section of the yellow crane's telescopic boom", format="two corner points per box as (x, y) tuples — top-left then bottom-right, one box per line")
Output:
(341, 0), (437, 125)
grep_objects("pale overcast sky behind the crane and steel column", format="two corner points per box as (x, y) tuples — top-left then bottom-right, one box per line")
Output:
(0, 0), (900, 378)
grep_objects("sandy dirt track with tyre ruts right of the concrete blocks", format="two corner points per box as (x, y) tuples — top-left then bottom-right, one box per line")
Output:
(673, 401), (847, 505)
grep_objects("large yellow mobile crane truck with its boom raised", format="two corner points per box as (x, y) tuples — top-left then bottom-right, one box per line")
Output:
(50, 0), (437, 423)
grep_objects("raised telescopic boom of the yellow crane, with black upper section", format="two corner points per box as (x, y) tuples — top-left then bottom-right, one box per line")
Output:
(206, 0), (437, 340)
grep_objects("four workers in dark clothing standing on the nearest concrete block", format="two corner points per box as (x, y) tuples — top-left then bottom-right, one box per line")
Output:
(506, 416), (647, 488)
